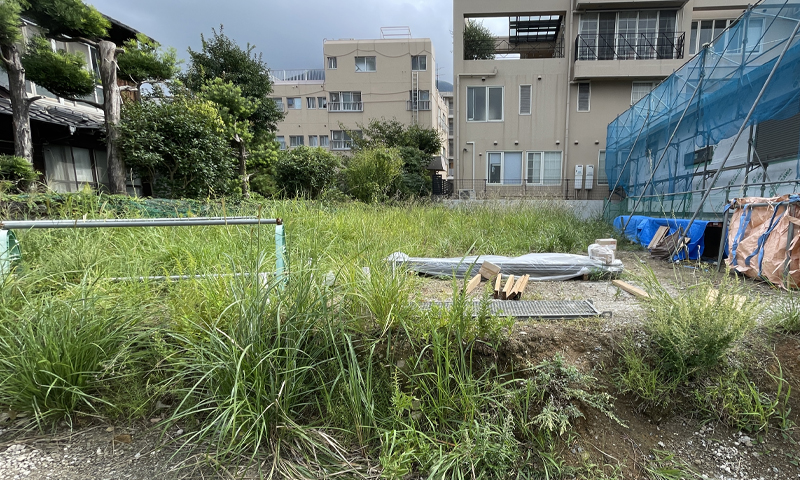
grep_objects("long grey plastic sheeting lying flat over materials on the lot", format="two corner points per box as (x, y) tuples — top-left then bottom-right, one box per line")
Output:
(386, 252), (622, 281)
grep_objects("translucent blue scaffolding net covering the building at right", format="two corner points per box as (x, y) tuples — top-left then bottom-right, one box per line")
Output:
(606, 0), (800, 223)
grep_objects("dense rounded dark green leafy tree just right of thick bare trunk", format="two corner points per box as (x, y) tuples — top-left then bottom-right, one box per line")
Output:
(119, 87), (236, 198)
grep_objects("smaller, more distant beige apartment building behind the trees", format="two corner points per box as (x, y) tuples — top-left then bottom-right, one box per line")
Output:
(270, 37), (447, 156)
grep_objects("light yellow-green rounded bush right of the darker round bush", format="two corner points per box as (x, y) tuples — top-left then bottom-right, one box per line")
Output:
(344, 148), (403, 203)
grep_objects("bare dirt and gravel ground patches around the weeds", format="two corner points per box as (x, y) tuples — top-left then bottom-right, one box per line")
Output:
(0, 252), (800, 480)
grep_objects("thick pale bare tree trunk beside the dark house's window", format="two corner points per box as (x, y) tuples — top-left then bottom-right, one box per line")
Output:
(98, 40), (127, 194)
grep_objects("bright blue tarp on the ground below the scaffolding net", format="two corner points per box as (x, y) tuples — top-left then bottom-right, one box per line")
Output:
(614, 215), (708, 261)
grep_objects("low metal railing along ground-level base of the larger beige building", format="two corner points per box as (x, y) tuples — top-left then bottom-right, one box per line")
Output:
(450, 179), (609, 200)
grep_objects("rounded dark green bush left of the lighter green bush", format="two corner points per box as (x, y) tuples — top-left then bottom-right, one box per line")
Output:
(275, 147), (340, 198)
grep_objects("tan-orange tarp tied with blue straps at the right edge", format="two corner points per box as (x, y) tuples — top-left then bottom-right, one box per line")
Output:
(726, 194), (800, 288)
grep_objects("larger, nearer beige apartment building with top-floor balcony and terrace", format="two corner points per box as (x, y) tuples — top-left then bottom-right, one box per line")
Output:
(452, 0), (763, 199)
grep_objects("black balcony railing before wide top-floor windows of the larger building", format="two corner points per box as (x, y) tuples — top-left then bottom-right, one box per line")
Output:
(575, 32), (686, 60)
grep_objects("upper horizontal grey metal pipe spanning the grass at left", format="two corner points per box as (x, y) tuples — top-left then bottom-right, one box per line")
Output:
(0, 217), (283, 230)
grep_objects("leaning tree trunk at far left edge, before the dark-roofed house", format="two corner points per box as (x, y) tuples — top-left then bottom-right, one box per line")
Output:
(2, 45), (33, 163)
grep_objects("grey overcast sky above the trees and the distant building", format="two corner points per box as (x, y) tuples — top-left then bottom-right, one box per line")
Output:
(86, 0), (453, 82)
